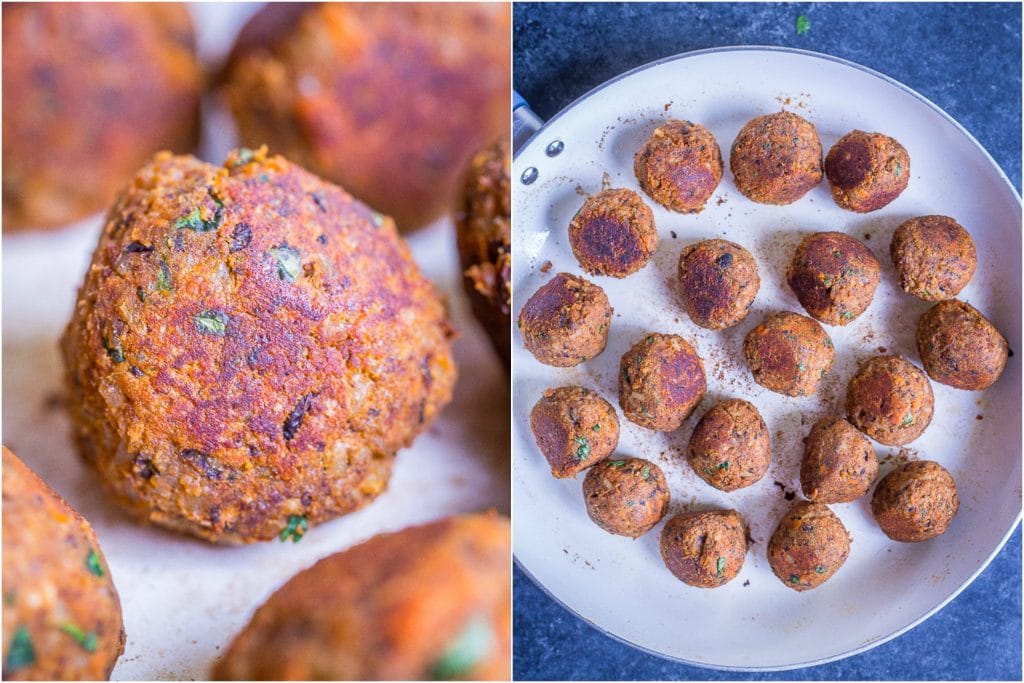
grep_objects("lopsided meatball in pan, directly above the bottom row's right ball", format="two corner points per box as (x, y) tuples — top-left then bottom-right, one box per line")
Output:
(800, 416), (879, 503)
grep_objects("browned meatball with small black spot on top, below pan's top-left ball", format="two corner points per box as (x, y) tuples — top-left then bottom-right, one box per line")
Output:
(679, 240), (761, 330)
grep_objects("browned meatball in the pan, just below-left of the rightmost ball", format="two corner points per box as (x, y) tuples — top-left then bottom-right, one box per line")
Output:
(846, 355), (935, 445)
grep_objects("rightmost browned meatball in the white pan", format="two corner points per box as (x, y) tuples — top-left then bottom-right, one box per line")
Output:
(916, 299), (1010, 391)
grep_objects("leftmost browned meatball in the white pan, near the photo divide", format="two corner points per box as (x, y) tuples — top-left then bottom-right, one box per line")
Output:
(517, 272), (612, 368)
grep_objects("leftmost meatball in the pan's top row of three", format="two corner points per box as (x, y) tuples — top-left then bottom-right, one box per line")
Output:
(633, 120), (722, 213)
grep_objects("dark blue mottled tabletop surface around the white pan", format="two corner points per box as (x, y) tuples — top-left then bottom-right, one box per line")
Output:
(513, 3), (1021, 681)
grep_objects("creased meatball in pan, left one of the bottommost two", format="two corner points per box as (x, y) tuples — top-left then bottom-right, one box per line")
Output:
(662, 510), (746, 588)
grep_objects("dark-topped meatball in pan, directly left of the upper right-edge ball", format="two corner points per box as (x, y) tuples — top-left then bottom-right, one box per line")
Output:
(785, 232), (882, 325)
